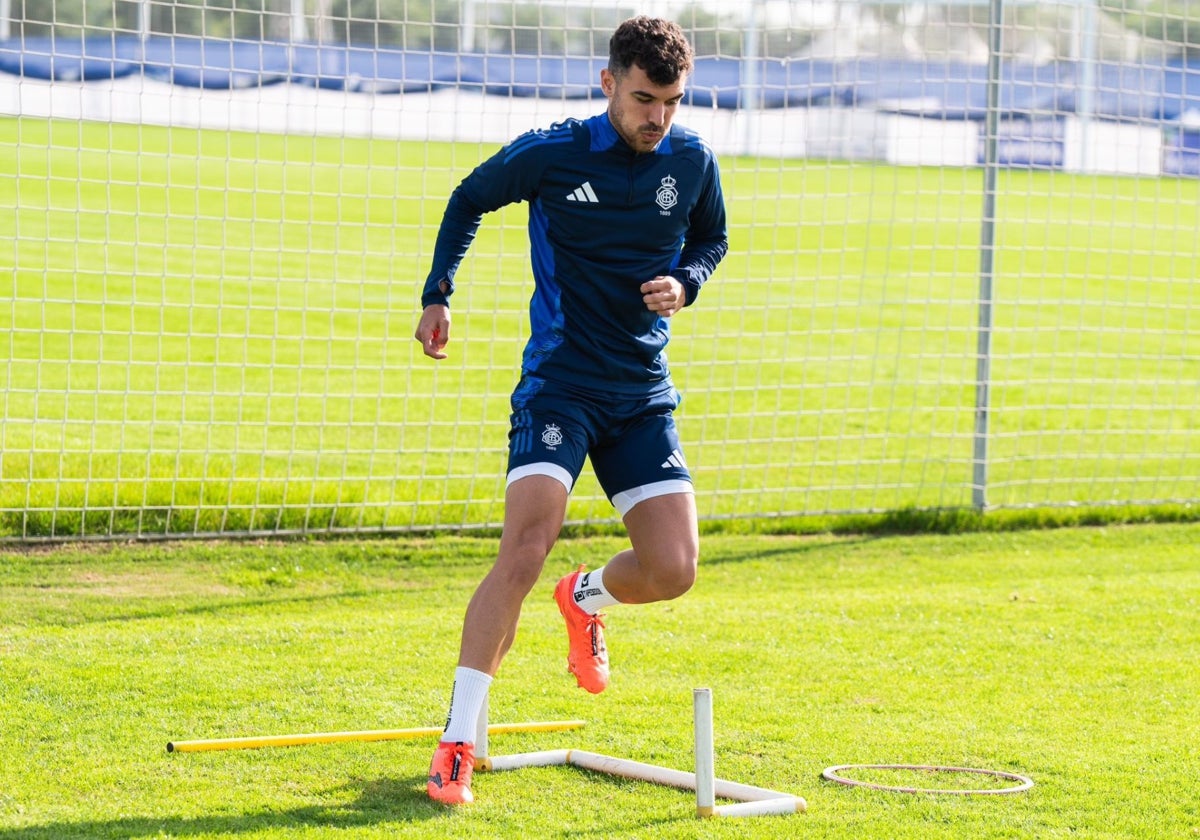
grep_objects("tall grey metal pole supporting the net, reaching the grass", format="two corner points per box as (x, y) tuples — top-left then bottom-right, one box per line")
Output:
(971, 0), (1004, 511)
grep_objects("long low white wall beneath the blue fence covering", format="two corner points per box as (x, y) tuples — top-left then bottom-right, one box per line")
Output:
(0, 73), (1163, 175)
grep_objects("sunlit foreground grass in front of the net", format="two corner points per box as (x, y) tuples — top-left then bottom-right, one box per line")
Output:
(0, 526), (1200, 840)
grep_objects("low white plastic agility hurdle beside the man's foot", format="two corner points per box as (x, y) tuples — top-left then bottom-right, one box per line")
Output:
(475, 689), (808, 817)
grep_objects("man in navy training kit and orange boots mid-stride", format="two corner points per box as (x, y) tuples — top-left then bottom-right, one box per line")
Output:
(415, 17), (728, 804)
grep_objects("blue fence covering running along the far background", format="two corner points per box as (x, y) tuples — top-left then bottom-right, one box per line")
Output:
(7, 36), (1200, 121)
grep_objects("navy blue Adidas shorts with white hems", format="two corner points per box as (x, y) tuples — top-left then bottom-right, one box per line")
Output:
(508, 377), (692, 516)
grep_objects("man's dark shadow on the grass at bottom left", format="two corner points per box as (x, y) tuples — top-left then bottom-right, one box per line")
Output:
(0, 775), (450, 840)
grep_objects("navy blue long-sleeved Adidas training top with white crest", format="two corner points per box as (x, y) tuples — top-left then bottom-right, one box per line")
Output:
(421, 113), (728, 395)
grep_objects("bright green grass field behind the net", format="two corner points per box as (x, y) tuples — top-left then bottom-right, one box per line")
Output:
(0, 119), (1200, 538)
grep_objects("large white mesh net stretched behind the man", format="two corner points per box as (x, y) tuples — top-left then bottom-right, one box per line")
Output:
(0, 0), (1200, 540)
